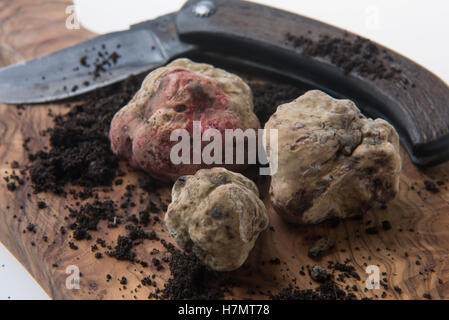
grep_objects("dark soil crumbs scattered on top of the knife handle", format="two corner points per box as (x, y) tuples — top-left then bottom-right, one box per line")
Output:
(285, 33), (408, 84)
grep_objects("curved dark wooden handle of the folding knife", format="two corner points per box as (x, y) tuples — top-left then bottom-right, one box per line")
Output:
(176, 0), (449, 166)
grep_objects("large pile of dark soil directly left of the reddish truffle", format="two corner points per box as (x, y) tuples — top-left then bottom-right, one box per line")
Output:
(29, 77), (142, 195)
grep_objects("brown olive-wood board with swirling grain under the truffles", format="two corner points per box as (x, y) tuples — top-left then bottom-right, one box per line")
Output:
(0, 0), (449, 299)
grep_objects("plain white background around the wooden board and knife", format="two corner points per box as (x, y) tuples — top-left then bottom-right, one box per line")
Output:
(0, 0), (449, 299)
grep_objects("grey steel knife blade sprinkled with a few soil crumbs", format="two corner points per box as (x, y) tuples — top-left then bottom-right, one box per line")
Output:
(0, 14), (195, 104)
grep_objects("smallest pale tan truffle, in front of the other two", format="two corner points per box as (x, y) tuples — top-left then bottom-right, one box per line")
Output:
(165, 168), (268, 271)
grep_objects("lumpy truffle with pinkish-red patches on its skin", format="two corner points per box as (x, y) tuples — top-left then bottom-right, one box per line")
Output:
(109, 59), (260, 181)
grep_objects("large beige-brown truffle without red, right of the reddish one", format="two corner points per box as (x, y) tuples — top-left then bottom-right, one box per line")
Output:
(265, 90), (401, 224)
